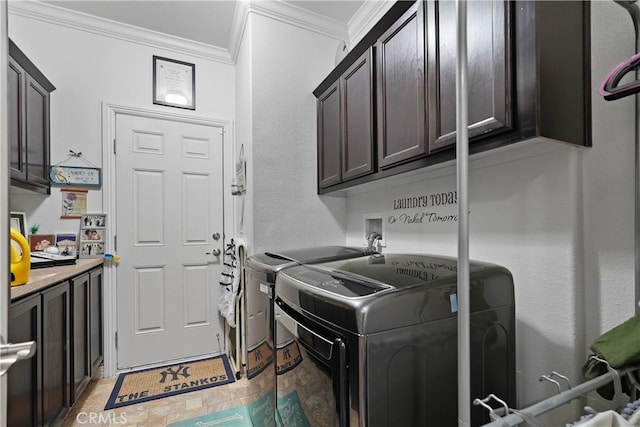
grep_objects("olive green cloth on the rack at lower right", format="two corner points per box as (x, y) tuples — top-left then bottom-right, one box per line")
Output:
(582, 313), (640, 400)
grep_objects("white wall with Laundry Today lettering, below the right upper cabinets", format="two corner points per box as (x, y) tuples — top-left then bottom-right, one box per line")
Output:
(340, 2), (637, 425)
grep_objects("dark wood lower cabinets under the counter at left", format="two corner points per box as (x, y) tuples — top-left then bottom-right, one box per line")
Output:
(7, 267), (103, 427)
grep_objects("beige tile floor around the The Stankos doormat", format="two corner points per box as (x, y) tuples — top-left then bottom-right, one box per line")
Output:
(62, 364), (269, 427)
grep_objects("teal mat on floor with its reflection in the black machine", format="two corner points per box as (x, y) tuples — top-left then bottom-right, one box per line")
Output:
(168, 390), (310, 427)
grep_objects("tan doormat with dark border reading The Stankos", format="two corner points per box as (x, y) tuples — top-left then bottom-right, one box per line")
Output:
(104, 354), (235, 410)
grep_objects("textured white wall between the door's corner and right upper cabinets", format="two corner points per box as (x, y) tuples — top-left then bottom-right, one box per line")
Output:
(238, 13), (345, 253)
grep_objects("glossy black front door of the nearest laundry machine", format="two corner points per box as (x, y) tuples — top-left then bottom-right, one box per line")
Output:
(275, 298), (348, 426)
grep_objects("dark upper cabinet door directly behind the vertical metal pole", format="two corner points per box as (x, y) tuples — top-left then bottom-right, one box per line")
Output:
(426, 1), (512, 151)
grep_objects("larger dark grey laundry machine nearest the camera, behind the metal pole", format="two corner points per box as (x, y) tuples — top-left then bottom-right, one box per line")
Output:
(274, 254), (516, 427)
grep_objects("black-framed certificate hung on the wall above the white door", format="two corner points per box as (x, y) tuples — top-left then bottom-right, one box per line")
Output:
(153, 55), (196, 110)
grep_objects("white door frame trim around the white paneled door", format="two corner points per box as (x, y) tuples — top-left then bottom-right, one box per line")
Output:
(102, 102), (234, 377)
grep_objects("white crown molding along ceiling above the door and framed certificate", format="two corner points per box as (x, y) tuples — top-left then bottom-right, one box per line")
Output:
(9, 1), (234, 65)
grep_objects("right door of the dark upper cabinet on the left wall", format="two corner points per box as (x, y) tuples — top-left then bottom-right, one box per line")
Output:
(26, 76), (49, 187)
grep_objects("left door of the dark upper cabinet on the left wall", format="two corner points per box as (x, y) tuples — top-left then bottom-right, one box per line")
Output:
(7, 58), (27, 180)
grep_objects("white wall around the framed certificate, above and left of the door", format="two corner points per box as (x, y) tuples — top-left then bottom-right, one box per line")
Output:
(9, 10), (235, 241)
